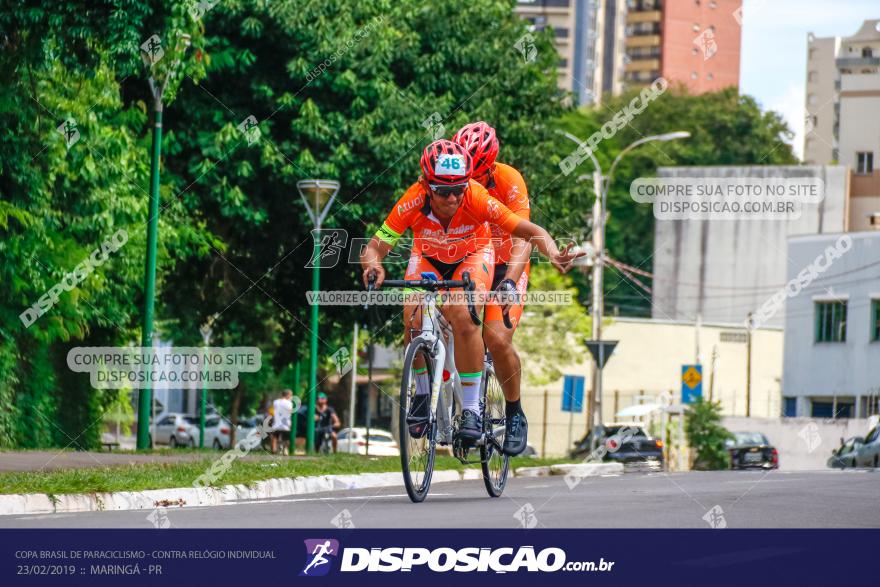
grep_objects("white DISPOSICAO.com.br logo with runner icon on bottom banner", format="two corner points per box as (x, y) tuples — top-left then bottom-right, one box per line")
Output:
(300, 539), (614, 577)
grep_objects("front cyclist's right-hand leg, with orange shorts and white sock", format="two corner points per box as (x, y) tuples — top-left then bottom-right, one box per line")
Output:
(443, 245), (495, 437)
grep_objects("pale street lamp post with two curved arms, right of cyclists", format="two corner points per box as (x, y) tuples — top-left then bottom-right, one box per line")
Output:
(559, 131), (691, 436)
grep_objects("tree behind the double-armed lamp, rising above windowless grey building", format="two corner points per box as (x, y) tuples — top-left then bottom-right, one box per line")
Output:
(544, 85), (797, 316)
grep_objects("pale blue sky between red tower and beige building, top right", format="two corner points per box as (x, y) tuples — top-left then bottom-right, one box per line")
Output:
(740, 0), (880, 156)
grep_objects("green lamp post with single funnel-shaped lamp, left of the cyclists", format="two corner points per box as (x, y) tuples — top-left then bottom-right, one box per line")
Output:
(296, 179), (339, 453)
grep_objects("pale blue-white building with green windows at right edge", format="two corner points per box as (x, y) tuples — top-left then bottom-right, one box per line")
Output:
(782, 232), (880, 418)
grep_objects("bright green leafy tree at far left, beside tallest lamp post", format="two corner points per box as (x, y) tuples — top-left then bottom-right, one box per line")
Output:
(0, 0), (207, 448)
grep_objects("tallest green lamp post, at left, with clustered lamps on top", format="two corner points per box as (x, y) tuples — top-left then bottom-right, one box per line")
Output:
(137, 34), (190, 449)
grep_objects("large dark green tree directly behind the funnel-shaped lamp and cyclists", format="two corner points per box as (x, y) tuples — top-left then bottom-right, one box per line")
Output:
(152, 0), (562, 422)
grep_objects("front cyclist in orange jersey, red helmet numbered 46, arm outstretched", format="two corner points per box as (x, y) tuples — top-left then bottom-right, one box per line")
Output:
(361, 140), (578, 440)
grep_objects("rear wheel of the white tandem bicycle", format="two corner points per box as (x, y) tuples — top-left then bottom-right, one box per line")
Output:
(480, 368), (510, 497)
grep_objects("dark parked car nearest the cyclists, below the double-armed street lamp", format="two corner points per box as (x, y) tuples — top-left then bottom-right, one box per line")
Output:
(569, 424), (663, 469)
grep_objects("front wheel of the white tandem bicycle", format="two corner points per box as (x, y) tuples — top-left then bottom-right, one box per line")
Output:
(398, 342), (437, 503)
